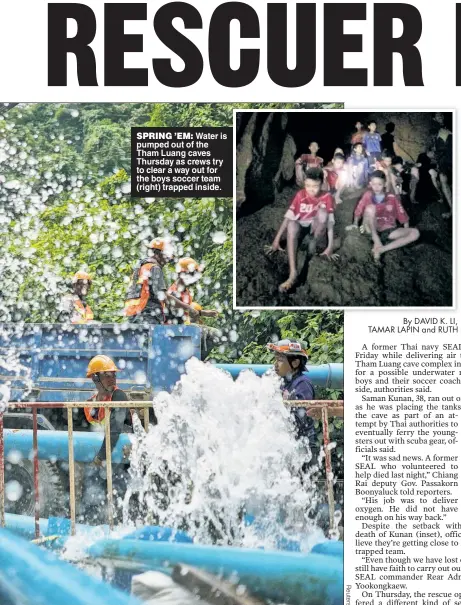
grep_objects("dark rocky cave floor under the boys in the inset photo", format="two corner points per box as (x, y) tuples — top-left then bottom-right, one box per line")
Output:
(236, 187), (453, 307)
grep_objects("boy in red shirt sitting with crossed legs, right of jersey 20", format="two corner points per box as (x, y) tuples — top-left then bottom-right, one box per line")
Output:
(346, 170), (419, 262)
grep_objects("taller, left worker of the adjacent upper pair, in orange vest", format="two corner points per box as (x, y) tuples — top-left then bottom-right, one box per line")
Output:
(124, 238), (198, 324)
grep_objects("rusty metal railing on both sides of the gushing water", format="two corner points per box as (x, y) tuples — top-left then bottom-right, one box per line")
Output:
(0, 400), (344, 538)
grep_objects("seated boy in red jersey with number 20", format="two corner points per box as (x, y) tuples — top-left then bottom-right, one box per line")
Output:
(266, 168), (338, 292)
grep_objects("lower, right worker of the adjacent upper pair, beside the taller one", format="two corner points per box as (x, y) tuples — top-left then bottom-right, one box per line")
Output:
(168, 257), (219, 324)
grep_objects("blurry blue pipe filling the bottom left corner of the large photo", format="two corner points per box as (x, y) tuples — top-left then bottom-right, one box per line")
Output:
(0, 529), (141, 605)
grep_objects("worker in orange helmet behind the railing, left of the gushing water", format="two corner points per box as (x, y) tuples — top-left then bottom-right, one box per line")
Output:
(84, 355), (135, 466)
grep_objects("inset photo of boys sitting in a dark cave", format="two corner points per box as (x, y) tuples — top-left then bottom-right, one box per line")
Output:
(234, 109), (454, 309)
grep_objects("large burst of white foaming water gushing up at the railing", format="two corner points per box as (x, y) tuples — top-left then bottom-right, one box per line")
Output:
(124, 358), (324, 550)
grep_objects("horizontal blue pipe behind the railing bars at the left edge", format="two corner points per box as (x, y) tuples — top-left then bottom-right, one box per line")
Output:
(4, 429), (130, 464)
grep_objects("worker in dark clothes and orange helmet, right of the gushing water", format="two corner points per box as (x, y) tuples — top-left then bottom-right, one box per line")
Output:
(267, 339), (320, 462)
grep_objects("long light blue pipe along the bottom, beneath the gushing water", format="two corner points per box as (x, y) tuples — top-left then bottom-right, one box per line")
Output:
(88, 540), (343, 605)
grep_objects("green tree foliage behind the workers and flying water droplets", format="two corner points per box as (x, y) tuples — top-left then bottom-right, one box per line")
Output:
(0, 103), (342, 363)
